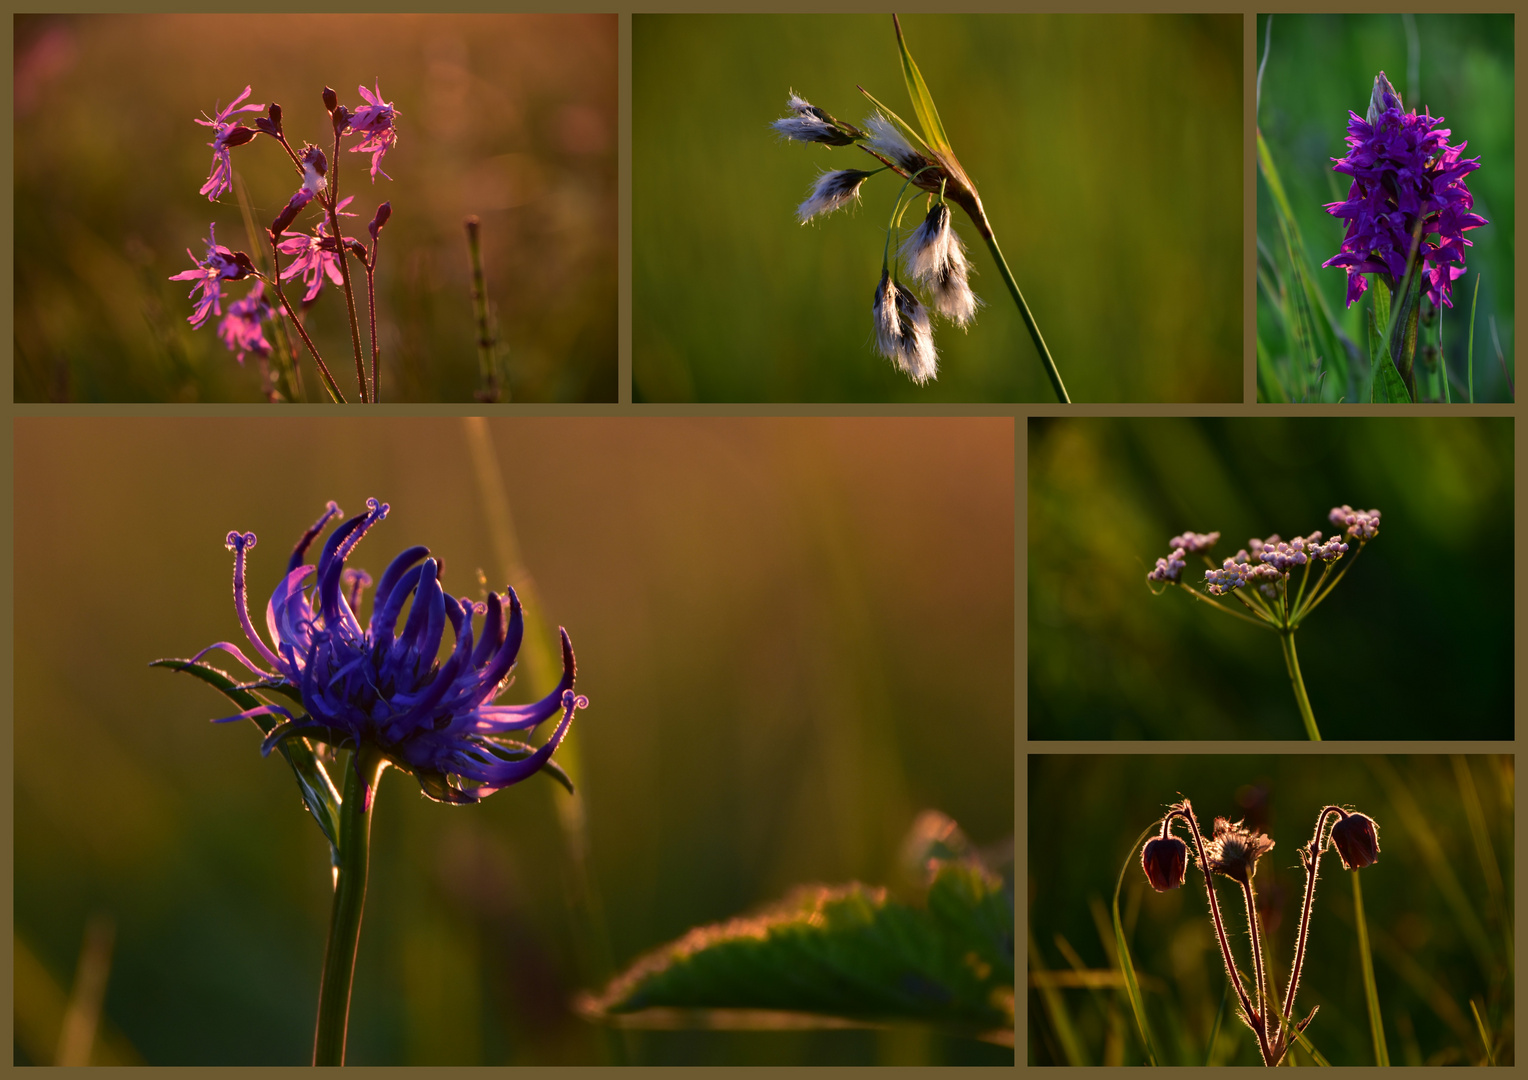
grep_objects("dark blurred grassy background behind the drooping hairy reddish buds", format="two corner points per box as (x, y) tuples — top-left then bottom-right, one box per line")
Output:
(1028, 757), (1516, 1065)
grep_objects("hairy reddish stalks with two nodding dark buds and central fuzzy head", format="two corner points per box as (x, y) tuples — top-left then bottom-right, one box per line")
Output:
(1141, 799), (1378, 1066)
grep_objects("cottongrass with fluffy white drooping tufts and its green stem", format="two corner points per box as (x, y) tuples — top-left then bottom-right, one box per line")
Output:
(772, 15), (1071, 402)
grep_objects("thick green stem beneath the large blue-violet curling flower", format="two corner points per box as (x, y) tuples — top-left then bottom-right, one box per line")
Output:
(313, 745), (387, 1065)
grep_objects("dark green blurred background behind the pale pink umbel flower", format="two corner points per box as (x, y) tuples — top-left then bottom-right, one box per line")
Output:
(1028, 417), (1514, 739)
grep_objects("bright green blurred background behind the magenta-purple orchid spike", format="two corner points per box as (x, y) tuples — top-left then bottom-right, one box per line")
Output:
(1258, 14), (1517, 402)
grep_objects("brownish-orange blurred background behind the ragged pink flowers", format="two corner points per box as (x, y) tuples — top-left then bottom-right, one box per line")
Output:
(15, 14), (616, 402)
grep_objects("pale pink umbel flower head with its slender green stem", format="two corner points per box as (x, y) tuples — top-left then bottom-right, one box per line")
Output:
(1146, 504), (1380, 741)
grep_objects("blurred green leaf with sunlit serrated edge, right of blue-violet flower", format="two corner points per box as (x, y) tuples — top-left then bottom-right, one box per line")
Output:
(581, 862), (1013, 1034)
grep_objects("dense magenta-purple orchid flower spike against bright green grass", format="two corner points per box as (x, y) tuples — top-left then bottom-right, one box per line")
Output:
(1322, 72), (1487, 307)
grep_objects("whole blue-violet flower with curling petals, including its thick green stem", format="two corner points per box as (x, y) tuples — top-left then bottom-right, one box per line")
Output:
(179, 500), (588, 1065)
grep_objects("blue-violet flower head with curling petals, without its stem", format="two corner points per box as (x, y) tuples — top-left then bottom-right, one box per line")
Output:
(197, 498), (588, 802)
